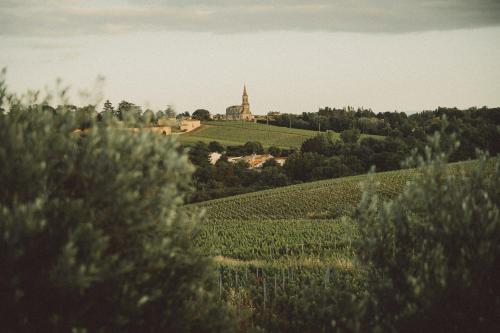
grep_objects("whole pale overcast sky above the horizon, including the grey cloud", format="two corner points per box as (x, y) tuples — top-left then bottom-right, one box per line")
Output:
(0, 0), (500, 114)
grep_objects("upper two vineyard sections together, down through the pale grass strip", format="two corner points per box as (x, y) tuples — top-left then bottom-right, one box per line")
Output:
(191, 161), (477, 269)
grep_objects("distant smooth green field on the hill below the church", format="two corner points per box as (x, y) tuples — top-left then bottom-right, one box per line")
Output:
(175, 121), (378, 148)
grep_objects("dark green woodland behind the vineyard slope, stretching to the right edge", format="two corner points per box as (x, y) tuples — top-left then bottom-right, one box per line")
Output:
(189, 108), (500, 201)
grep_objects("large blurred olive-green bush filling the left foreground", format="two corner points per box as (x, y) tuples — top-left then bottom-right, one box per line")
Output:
(0, 76), (234, 332)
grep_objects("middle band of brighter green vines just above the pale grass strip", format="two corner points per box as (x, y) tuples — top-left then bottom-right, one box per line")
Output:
(195, 220), (349, 260)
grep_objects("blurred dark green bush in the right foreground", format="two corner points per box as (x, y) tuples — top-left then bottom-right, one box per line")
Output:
(356, 132), (500, 332)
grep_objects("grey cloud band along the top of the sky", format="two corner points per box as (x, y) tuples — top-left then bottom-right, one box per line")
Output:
(0, 0), (500, 36)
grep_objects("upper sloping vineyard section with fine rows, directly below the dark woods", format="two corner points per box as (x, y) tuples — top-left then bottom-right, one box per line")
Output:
(194, 161), (480, 220)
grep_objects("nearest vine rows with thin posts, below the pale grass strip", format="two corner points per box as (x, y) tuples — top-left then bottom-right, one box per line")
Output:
(214, 265), (363, 332)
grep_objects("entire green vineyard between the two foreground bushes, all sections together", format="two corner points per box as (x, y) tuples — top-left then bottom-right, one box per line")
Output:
(186, 161), (475, 331)
